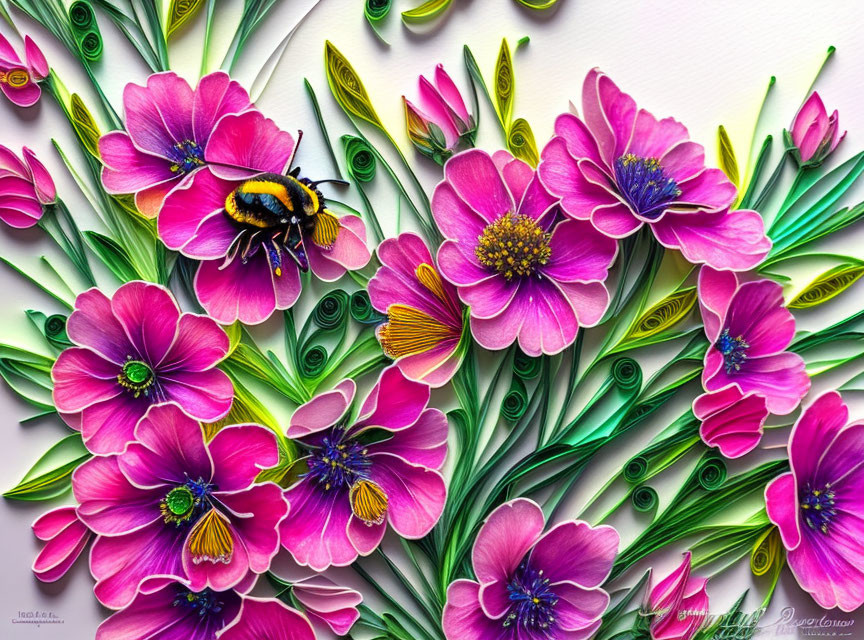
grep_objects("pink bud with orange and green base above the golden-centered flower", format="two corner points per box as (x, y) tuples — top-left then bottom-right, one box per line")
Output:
(402, 64), (477, 164)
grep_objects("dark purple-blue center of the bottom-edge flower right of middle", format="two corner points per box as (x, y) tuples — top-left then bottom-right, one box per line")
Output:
(504, 562), (558, 638)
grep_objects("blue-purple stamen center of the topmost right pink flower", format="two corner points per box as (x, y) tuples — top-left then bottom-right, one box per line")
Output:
(615, 153), (681, 219)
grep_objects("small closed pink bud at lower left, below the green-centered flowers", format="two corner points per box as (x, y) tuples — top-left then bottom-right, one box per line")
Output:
(33, 507), (91, 582)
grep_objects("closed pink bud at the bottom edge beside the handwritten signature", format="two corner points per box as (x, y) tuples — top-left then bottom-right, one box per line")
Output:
(649, 551), (708, 640)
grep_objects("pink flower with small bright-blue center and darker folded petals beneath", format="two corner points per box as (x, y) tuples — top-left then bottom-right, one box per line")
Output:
(694, 266), (810, 458)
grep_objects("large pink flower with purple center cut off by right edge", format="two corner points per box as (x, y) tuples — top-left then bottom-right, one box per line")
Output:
(765, 391), (864, 611)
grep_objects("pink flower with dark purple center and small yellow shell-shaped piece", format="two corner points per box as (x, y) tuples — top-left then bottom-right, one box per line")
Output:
(281, 366), (447, 571)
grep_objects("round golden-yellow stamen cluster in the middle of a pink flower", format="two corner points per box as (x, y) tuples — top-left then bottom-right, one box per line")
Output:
(474, 213), (552, 280)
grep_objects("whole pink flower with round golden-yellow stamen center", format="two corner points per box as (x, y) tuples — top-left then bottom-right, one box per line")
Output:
(432, 150), (617, 356)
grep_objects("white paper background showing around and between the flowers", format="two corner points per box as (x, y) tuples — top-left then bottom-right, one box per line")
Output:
(0, 0), (864, 640)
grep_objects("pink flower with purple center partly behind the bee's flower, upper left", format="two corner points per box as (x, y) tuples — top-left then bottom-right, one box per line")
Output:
(99, 71), (252, 218)
